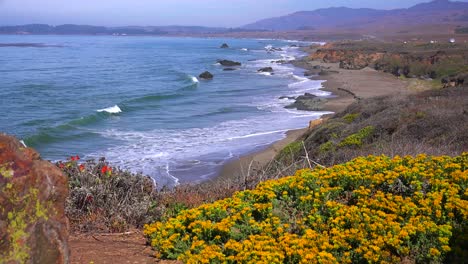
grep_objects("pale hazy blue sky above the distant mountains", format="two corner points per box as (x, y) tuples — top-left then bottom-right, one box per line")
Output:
(0, 0), (468, 27)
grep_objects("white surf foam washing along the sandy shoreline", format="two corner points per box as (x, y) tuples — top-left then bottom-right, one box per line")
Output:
(87, 38), (328, 186)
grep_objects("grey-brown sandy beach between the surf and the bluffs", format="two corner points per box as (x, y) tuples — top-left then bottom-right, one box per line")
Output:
(218, 54), (410, 182)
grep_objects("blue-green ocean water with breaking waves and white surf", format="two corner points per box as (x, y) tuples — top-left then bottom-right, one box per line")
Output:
(0, 36), (327, 188)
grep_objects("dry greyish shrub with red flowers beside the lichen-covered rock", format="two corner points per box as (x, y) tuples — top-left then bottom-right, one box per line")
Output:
(57, 158), (159, 232)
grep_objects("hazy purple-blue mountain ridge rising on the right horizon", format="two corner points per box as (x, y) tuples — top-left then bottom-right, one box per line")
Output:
(242, 0), (468, 31)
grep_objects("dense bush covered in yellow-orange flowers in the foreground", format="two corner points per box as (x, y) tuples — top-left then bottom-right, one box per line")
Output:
(144, 153), (468, 263)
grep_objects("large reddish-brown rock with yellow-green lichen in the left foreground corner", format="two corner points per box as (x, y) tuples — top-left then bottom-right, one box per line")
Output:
(0, 134), (69, 264)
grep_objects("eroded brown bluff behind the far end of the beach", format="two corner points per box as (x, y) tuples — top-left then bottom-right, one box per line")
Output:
(309, 42), (468, 86)
